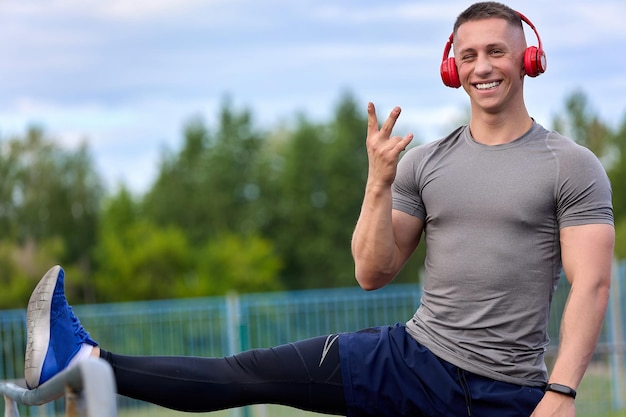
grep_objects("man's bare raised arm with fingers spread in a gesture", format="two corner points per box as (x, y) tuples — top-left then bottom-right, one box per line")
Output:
(352, 103), (423, 290)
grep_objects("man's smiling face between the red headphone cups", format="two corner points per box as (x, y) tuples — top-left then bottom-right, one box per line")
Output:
(454, 18), (526, 115)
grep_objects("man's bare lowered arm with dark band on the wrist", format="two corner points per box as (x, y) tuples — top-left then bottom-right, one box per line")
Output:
(532, 224), (615, 417)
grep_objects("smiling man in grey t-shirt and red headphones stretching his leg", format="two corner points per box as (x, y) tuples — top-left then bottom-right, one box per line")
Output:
(26, 2), (614, 417)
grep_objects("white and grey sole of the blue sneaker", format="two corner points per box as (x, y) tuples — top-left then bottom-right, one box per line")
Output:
(24, 265), (61, 388)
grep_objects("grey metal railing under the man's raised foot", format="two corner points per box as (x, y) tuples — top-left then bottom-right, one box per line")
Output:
(0, 358), (117, 417)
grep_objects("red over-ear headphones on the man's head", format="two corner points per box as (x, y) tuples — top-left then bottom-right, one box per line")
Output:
(440, 12), (547, 88)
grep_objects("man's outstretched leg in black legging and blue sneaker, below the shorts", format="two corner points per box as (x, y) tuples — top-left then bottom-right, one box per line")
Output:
(25, 266), (346, 414)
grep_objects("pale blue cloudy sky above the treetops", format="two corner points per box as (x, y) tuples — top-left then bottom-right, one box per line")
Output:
(0, 0), (626, 193)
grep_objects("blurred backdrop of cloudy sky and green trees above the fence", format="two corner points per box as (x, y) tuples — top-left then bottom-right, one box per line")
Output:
(0, 0), (626, 309)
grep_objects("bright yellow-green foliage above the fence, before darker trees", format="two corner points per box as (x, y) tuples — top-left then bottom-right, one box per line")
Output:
(93, 187), (281, 301)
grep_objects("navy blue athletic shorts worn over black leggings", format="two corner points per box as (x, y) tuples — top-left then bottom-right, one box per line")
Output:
(339, 324), (543, 417)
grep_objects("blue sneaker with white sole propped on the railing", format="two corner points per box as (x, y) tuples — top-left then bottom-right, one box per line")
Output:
(24, 265), (98, 389)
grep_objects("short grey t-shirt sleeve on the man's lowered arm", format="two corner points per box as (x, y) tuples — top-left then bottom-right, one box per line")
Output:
(557, 145), (614, 228)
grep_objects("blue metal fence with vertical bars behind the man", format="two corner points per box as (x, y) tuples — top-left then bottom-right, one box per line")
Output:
(0, 262), (626, 417)
